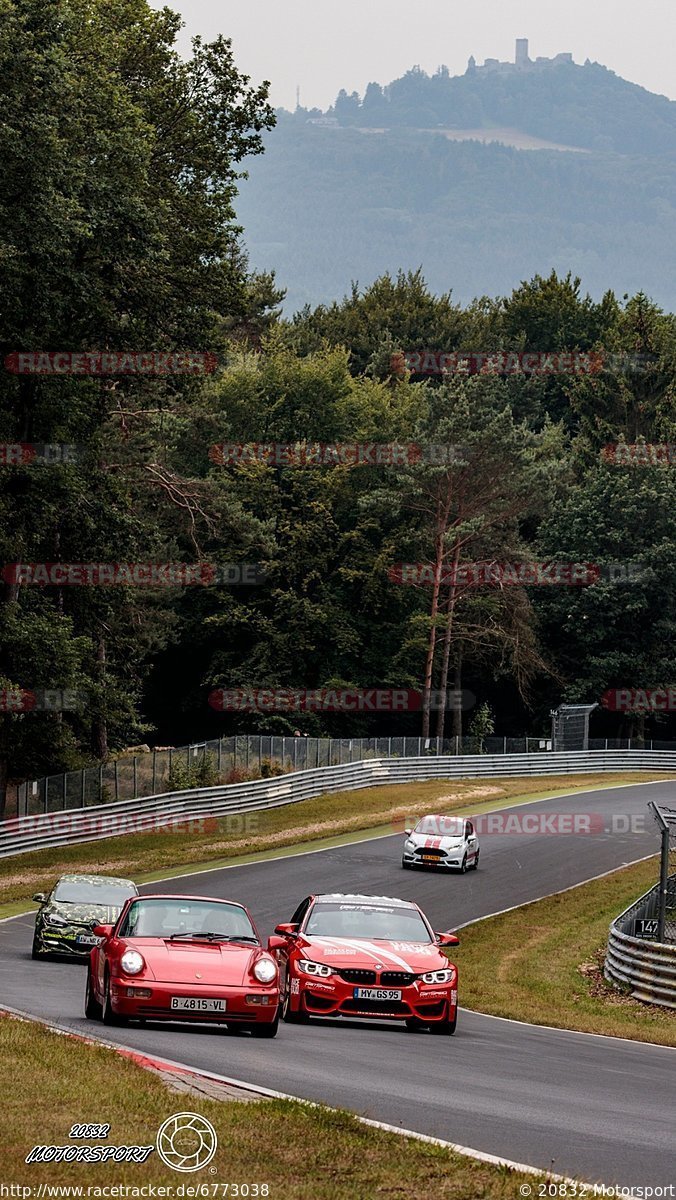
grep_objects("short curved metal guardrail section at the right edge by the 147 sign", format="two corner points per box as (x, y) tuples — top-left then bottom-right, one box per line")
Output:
(604, 876), (676, 1008)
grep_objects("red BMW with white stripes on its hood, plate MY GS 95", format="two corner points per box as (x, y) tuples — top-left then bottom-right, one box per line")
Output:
(268, 894), (459, 1033)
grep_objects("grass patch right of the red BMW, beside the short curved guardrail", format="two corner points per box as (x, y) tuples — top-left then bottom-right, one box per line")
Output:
(454, 858), (676, 1046)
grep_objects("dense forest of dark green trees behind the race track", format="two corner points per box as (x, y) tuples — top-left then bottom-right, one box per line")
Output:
(0, 0), (676, 811)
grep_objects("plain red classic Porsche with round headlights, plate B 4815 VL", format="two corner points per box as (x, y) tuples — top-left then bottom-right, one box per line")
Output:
(85, 895), (280, 1038)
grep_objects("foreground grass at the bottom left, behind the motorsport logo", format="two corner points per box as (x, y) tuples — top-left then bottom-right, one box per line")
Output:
(0, 1016), (544, 1200)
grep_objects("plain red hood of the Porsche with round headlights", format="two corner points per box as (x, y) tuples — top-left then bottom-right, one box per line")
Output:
(120, 937), (269, 986)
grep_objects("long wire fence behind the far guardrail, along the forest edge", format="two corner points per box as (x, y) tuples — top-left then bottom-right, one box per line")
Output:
(5, 734), (676, 817)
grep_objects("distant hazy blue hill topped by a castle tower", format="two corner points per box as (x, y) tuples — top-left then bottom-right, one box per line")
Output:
(238, 64), (676, 311)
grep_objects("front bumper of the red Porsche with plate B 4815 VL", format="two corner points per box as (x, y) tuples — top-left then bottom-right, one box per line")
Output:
(110, 976), (280, 1025)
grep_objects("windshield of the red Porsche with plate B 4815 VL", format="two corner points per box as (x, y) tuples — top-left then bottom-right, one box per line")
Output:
(119, 896), (258, 944)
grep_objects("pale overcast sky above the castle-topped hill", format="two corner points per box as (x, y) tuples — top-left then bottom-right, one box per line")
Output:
(166, 0), (676, 108)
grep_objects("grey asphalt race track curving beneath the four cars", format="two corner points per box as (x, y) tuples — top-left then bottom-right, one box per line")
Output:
(0, 781), (676, 1187)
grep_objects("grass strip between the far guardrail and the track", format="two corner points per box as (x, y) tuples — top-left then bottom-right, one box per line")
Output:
(0, 772), (670, 917)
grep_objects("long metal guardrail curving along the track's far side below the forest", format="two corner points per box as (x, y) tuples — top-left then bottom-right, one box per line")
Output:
(0, 750), (676, 857)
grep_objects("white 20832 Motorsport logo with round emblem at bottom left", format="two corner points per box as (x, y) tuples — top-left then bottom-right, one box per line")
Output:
(25, 1112), (219, 1172)
